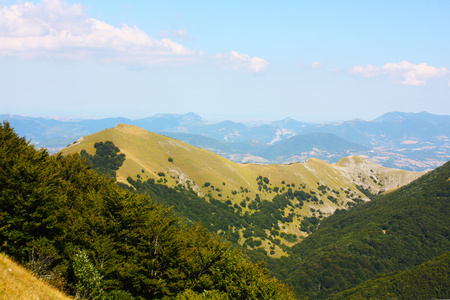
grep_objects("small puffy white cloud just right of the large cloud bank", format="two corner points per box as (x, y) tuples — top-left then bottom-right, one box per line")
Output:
(215, 51), (269, 73)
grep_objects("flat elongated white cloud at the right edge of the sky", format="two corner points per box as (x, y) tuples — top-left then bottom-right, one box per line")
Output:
(351, 61), (450, 86)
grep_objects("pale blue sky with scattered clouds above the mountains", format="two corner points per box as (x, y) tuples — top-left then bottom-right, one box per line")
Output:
(0, 0), (450, 122)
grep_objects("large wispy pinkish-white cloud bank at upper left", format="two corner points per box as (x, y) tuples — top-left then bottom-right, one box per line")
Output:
(0, 0), (267, 72)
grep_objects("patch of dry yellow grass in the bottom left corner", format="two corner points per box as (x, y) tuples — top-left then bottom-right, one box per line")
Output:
(0, 253), (73, 300)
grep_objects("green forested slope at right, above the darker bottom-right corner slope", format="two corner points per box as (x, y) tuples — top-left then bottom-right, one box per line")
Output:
(278, 162), (450, 298)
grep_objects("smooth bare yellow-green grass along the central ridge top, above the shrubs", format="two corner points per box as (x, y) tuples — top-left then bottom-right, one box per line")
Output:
(63, 124), (419, 203)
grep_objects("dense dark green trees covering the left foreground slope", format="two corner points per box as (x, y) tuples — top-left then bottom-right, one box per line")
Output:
(0, 123), (294, 299)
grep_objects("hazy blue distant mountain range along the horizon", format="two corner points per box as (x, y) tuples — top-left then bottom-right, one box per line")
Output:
(0, 112), (450, 171)
